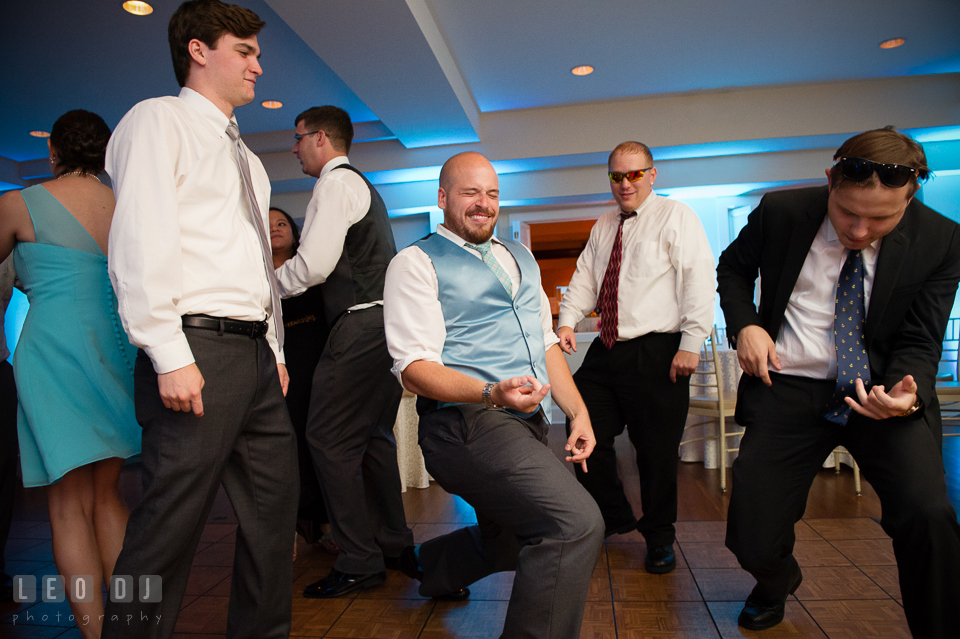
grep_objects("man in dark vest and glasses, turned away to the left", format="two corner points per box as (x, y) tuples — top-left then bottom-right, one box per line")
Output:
(277, 106), (413, 599)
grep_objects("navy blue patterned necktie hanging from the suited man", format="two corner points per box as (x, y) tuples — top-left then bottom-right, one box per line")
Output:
(824, 251), (870, 425)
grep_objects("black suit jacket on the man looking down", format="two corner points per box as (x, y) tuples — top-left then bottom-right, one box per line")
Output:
(717, 187), (960, 442)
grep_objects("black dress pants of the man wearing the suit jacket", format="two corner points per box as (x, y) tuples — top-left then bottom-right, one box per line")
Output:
(726, 373), (960, 638)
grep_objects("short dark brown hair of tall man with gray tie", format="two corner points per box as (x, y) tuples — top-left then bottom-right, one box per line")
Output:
(167, 0), (266, 87)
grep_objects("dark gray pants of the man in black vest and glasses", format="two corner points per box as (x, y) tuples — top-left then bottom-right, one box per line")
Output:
(306, 306), (413, 574)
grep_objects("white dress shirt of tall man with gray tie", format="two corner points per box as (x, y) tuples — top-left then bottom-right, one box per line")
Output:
(106, 88), (284, 373)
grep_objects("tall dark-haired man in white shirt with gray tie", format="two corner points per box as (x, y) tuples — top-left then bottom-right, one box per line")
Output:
(103, 0), (297, 637)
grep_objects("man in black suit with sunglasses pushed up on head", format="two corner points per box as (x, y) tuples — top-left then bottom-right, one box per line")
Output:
(717, 127), (960, 637)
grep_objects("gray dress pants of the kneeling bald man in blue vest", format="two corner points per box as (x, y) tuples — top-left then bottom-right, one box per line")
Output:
(420, 404), (603, 639)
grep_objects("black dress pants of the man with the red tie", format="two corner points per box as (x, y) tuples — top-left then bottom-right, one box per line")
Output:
(568, 333), (690, 546)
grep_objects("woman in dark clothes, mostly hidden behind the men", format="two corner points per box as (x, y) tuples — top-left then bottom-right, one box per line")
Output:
(270, 208), (339, 552)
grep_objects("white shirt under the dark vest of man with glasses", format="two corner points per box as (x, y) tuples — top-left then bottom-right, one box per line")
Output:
(277, 155), (382, 311)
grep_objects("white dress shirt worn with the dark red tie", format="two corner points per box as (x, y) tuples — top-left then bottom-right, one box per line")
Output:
(559, 193), (717, 353)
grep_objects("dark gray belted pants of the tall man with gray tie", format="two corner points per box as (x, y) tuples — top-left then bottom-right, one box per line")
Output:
(102, 328), (297, 639)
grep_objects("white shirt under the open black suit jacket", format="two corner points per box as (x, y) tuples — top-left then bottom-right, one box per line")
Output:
(776, 216), (881, 379)
